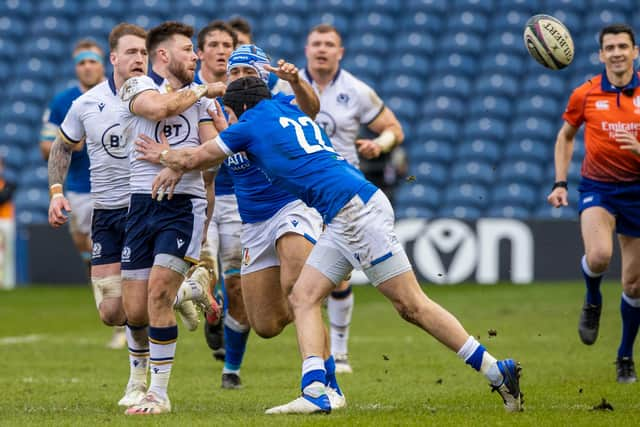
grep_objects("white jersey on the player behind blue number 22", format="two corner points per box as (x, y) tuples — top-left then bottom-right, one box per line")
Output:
(300, 68), (384, 168)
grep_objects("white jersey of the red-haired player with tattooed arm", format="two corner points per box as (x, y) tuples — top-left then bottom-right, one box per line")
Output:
(60, 76), (129, 209)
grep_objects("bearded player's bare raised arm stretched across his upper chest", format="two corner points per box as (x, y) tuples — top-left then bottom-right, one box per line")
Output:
(129, 82), (226, 121)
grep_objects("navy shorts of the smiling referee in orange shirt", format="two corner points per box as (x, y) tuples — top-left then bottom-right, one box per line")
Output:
(578, 177), (640, 237)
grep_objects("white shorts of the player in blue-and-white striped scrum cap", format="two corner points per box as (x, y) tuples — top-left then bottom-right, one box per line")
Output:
(242, 200), (322, 274)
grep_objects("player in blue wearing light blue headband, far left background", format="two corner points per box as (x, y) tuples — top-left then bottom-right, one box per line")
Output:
(40, 40), (127, 349)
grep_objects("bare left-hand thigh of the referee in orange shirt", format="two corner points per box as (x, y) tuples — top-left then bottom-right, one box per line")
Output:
(580, 206), (616, 273)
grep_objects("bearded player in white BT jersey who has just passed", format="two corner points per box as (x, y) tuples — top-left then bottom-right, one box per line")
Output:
(120, 22), (225, 415)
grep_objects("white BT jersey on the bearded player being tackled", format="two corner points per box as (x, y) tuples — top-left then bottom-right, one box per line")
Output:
(120, 71), (215, 197)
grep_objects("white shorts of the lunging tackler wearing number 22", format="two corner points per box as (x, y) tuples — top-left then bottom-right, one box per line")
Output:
(307, 190), (412, 286)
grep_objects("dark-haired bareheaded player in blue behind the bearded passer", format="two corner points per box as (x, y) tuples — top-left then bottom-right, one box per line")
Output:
(195, 20), (241, 374)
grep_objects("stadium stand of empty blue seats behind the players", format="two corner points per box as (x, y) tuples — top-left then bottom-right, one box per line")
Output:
(0, 0), (640, 234)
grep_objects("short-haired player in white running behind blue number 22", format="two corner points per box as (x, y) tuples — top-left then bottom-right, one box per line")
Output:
(300, 24), (404, 373)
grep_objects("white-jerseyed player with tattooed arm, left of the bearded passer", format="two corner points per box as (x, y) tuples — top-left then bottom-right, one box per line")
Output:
(49, 24), (156, 406)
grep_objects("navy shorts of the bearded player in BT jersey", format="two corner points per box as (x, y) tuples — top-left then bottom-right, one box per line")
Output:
(121, 194), (207, 270)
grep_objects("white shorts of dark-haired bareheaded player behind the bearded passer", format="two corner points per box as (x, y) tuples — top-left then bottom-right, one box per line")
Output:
(207, 194), (242, 277)
